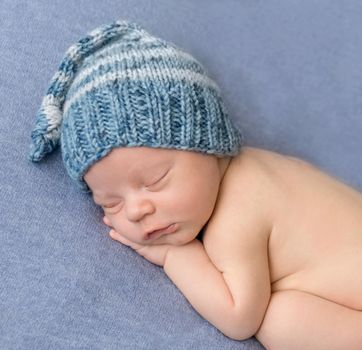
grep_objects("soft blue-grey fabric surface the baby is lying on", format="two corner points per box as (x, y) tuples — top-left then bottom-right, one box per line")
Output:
(0, 0), (362, 350)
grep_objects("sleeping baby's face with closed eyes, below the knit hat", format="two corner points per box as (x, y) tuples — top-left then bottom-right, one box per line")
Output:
(84, 147), (229, 245)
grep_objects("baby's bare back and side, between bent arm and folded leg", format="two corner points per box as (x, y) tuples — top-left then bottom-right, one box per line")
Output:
(235, 147), (362, 310)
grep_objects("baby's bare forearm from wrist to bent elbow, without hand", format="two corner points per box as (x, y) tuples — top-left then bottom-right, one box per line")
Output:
(163, 240), (252, 340)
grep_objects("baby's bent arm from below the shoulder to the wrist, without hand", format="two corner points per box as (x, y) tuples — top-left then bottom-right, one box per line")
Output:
(164, 174), (272, 340)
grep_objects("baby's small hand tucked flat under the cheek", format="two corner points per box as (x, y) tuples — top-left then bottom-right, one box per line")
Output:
(103, 217), (173, 266)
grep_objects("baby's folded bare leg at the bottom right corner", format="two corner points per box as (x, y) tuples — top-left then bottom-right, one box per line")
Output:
(255, 290), (362, 350)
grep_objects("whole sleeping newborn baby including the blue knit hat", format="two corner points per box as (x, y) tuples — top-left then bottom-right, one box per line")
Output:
(29, 21), (362, 350)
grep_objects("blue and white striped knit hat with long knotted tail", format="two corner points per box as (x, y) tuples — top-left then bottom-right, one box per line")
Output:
(29, 21), (243, 192)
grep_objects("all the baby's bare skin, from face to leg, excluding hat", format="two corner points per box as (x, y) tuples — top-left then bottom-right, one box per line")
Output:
(85, 147), (362, 350)
